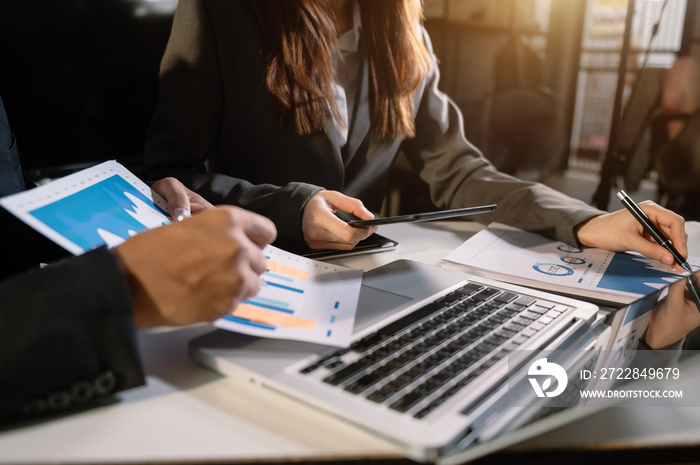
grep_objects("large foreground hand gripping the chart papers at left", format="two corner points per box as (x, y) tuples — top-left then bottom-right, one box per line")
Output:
(114, 206), (277, 329)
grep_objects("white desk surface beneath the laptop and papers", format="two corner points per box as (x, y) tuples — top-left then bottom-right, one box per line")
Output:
(0, 222), (700, 463)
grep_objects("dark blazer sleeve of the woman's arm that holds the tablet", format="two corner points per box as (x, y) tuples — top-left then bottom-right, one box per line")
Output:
(143, 0), (321, 247)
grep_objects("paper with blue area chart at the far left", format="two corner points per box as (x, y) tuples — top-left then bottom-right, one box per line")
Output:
(0, 161), (170, 255)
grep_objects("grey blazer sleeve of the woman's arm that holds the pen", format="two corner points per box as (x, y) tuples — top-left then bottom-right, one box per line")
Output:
(402, 27), (604, 245)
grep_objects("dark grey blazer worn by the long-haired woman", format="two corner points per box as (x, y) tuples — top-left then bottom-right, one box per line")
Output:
(144, 0), (601, 249)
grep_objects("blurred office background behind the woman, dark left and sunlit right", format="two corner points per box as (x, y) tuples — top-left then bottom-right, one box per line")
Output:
(0, 0), (700, 219)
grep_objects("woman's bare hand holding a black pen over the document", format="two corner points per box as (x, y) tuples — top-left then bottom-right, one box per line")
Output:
(576, 200), (688, 272)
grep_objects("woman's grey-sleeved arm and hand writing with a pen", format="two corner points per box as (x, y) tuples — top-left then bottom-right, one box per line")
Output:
(402, 27), (687, 266)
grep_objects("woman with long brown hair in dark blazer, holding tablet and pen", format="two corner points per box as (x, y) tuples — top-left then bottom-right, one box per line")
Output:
(144, 0), (685, 266)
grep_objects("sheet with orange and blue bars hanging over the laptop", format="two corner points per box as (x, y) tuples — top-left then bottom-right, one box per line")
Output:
(214, 246), (362, 346)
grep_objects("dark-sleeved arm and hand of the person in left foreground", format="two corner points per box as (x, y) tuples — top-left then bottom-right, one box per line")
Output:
(0, 207), (276, 423)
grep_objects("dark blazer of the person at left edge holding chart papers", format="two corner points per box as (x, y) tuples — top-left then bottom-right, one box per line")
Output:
(0, 95), (144, 423)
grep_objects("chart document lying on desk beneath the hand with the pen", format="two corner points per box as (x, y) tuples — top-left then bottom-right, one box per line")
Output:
(440, 223), (700, 306)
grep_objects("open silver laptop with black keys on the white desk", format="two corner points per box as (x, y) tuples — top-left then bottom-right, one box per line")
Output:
(190, 260), (696, 465)
